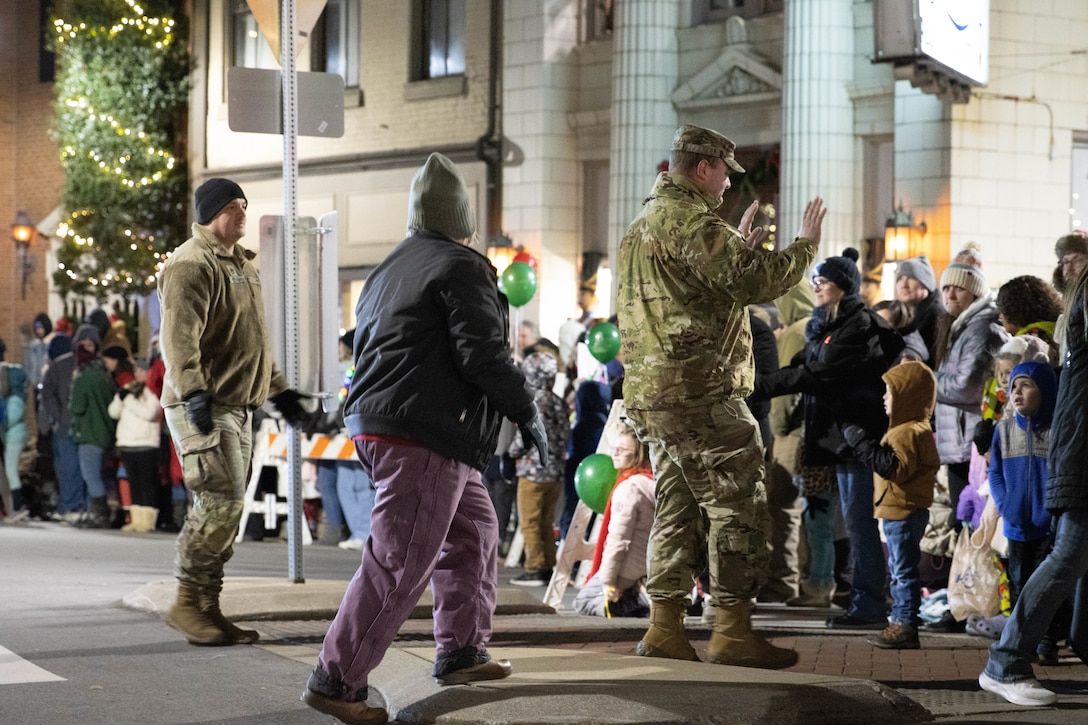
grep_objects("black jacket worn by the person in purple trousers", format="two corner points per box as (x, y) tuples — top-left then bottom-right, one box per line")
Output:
(344, 232), (535, 470)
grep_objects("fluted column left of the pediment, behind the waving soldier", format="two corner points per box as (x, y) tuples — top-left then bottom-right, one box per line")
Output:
(597, 0), (680, 296)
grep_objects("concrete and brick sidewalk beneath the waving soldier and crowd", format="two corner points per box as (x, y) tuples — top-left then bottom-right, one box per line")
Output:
(124, 572), (1088, 725)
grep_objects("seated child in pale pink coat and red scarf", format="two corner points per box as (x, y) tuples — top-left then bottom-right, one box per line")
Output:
(573, 427), (655, 617)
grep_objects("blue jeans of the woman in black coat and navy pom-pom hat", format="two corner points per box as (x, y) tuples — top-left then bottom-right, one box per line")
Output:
(836, 462), (887, 620)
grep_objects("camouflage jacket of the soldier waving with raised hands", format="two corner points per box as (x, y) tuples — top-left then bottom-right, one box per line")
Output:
(617, 172), (816, 410)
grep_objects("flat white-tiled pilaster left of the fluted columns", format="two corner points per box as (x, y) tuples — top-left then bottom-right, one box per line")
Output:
(503, 0), (582, 340)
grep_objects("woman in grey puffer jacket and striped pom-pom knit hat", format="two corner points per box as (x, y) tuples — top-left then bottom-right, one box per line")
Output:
(934, 243), (1009, 530)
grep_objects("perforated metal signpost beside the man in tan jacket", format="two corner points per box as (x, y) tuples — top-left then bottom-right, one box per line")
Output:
(280, 0), (306, 583)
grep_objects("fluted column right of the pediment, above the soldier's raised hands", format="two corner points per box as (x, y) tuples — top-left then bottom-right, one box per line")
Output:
(778, 0), (864, 257)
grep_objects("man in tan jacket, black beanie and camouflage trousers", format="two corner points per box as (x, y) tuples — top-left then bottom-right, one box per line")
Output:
(153, 179), (307, 644)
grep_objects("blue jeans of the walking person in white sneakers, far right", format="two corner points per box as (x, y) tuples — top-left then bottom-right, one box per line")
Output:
(986, 508), (1088, 683)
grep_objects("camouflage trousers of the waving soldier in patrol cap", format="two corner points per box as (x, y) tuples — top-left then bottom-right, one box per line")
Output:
(627, 400), (770, 606)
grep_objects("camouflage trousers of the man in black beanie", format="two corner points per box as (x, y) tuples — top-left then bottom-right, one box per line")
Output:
(166, 405), (252, 587)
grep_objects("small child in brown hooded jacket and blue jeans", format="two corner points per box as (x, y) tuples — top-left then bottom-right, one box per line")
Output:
(842, 360), (941, 650)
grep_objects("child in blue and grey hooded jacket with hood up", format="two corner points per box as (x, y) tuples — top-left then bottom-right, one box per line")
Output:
(989, 363), (1063, 664)
